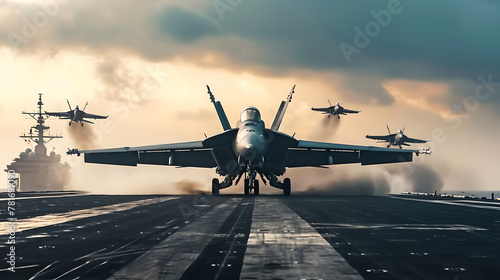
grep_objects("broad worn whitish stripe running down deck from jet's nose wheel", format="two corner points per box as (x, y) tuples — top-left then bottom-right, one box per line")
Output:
(240, 197), (363, 279)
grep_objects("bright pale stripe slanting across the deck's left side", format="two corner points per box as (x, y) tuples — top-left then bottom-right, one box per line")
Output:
(0, 197), (177, 235)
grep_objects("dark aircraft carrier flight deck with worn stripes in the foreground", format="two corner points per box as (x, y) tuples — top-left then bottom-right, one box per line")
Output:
(0, 192), (500, 279)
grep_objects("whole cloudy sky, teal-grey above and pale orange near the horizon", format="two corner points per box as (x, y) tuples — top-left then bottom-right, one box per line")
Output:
(0, 0), (500, 193)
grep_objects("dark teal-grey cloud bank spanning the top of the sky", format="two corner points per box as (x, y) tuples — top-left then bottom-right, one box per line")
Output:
(0, 0), (500, 110)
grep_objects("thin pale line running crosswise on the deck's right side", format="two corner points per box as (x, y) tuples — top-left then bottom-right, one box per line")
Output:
(311, 223), (487, 231)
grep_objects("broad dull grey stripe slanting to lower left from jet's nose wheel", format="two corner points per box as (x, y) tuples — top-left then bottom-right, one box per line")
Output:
(108, 198), (242, 280)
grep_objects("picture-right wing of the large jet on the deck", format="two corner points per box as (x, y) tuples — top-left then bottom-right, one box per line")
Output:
(285, 140), (419, 167)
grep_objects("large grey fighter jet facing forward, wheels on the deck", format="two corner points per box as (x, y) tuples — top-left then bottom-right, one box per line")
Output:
(68, 86), (426, 195)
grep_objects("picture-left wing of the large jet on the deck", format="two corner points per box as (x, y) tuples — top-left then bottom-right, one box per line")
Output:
(68, 129), (237, 168)
